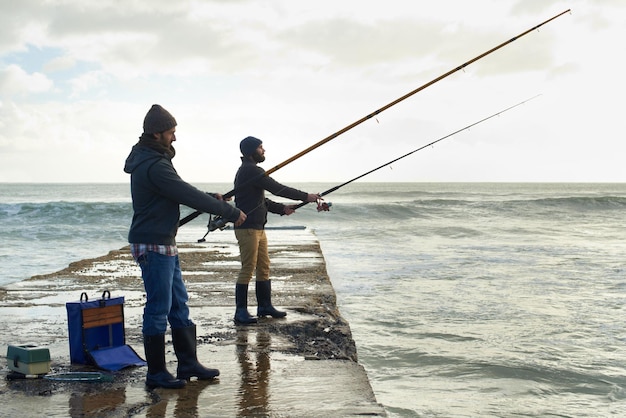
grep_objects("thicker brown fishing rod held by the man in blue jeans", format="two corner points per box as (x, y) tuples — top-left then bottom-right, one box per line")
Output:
(178, 9), (571, 226)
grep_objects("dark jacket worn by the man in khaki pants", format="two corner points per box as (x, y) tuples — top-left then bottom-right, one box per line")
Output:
(235, 157), (308, 229)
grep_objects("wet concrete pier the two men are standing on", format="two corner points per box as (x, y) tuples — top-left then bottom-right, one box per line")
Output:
(0, 230), (386, 417)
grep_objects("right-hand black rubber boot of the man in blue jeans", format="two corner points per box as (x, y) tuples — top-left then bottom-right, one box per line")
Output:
(172, 325), (220, 380)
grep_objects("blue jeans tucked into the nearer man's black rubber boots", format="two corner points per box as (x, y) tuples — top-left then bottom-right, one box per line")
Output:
(137, 251), (193, 335)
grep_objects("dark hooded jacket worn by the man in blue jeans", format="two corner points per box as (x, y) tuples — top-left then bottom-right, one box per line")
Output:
(124, 143), (240, 245)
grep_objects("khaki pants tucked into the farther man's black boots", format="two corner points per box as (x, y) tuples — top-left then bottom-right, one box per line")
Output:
(235, 229), (270, 284)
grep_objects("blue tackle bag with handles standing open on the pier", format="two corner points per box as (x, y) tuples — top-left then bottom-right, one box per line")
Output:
(65, 290), (146, 371)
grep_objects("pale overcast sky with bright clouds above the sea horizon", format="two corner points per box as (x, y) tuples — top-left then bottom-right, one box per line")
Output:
(0, 0), (626, 184)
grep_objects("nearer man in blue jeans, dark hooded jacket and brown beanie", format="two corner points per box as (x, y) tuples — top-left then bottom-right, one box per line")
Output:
(124, 105), (246, 388)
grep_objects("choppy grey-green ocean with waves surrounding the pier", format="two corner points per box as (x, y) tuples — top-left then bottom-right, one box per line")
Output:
(0, 182), (626, 417)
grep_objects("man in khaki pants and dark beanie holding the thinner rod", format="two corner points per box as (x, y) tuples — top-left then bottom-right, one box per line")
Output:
(234, 136), (321, 325)
